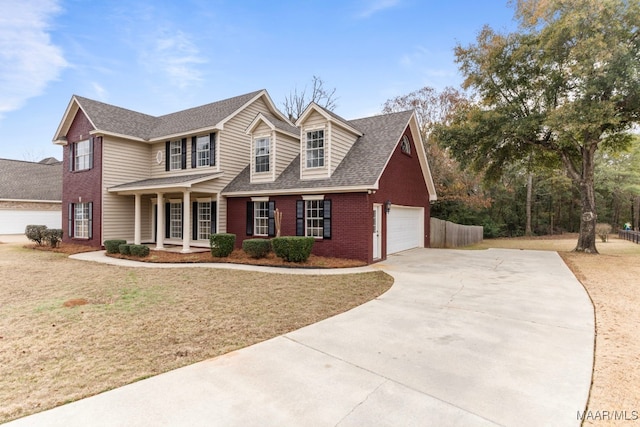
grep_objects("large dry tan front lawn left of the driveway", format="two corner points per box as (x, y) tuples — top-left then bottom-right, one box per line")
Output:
(0, 243), (393, 423)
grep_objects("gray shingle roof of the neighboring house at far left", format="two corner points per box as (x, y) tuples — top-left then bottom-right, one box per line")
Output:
(0, 159), (62, 200)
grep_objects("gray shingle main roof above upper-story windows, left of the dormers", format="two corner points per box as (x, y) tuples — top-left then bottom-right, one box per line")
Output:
(74, 90), (261, 140)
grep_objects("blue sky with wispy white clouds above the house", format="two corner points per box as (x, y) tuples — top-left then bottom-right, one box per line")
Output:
(0, 0), (516, 161)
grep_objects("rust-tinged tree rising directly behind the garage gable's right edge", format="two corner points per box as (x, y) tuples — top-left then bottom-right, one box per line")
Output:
(382, 86), (489, 211)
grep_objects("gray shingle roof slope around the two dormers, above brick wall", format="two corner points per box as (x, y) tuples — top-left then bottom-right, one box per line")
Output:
(223, 111), (413, 194)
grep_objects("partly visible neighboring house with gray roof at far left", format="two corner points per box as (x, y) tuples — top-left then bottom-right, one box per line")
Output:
(0, 157), (62, 234)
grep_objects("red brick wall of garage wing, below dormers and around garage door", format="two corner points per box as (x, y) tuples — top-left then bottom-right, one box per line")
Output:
(227, 129), (430, 263)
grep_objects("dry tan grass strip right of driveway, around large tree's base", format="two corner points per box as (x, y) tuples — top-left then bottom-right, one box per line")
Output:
(472, 235), (640, 426)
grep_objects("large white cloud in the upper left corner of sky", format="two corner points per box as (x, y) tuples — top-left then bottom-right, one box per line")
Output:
(0, 0), (68, 118)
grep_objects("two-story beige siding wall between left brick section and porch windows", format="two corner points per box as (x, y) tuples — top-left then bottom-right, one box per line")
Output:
(102, 137), (151, 241)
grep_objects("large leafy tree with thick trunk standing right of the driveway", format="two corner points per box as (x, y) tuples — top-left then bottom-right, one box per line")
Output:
(438, 0), (640, 253)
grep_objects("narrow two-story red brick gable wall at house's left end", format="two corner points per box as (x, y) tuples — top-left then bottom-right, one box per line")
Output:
(62, 110), (102, 247)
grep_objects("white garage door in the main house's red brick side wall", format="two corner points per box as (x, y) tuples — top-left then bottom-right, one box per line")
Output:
(387, 205), (424, 254)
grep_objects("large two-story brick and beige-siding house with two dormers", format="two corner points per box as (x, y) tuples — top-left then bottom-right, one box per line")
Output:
(54, 90), (436, 263)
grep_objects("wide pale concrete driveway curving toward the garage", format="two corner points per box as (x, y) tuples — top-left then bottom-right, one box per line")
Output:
(7, 249), (594, 427)
